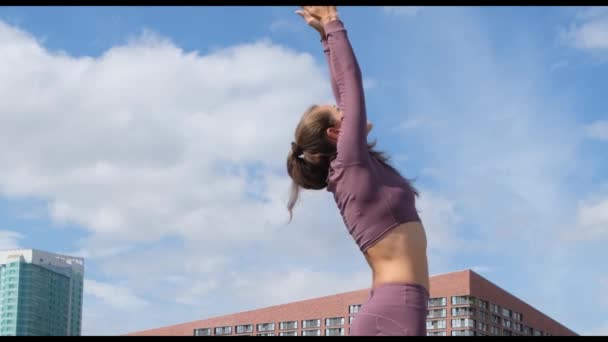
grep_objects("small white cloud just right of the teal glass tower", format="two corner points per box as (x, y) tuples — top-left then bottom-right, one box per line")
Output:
(84, 279), (148, 311)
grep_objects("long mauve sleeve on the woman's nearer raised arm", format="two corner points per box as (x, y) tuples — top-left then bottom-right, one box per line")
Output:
(325, 20), (369, 165)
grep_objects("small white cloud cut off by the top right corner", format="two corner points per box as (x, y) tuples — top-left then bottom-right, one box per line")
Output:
(562, 7), (608, 50)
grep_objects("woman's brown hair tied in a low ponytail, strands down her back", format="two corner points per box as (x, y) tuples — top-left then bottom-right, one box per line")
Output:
(287, 105), (418, 221)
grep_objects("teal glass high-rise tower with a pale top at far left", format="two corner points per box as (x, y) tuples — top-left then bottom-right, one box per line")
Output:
(0, 249), (84, 336)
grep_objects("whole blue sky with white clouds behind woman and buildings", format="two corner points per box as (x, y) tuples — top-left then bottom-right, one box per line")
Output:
(0, 7), (608, 335)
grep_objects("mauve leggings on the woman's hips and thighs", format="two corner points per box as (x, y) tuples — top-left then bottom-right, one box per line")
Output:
(350, 283), (429, 336)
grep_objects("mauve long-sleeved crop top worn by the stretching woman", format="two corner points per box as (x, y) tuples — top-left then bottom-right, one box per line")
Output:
(321, 20), (420, 253)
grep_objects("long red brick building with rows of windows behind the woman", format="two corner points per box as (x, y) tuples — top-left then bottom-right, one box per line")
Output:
(129, 270), (576, 336)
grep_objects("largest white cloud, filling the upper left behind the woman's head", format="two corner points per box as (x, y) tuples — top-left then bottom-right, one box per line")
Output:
(0, 18), (328, 253)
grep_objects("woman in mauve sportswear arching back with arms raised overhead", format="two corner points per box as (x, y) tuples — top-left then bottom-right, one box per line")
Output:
(287, 6), (429, 335)
